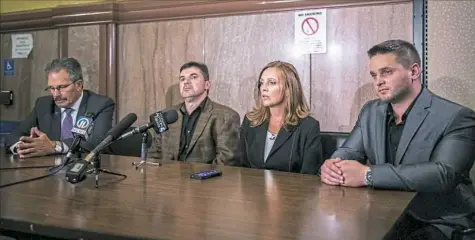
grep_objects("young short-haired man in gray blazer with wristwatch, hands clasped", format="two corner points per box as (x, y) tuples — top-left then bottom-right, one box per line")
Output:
(320, 40), (475, 239)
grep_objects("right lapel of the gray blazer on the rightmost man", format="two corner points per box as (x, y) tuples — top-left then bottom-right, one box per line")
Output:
(394, 89), (432, 165)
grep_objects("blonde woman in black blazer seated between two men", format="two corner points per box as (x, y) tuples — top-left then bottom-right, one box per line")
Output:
(241, 61), (323, 174)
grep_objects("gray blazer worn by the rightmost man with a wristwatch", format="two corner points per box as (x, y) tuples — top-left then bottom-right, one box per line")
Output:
(332, 89), (475, 232)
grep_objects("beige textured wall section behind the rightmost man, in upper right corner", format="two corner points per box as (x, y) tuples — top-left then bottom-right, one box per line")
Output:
(428, 0), (475, 109)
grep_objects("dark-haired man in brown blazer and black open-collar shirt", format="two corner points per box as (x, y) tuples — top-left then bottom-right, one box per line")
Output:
(149, 62), (240, 165)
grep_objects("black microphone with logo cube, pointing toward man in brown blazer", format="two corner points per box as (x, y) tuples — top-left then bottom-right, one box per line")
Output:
(117, 109), (178, 140)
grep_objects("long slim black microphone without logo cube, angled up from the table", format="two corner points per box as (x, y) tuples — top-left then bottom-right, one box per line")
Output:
(66, 113), (137, 183)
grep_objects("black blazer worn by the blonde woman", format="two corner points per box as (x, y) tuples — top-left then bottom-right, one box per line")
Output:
(240, 117), (323, 174)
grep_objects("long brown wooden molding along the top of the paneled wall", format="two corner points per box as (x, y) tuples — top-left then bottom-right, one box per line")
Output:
(0, 0), (410, 33)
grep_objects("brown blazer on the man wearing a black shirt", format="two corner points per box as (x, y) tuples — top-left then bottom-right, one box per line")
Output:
(148, 98), (240, 165)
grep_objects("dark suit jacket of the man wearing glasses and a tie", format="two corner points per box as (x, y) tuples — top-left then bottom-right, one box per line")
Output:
(6, 90), (115, 150)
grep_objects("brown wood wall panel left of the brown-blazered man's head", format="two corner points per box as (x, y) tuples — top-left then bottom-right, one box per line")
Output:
(117, 19), (205, 124)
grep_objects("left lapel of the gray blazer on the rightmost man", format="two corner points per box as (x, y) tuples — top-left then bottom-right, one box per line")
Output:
(374, 103), (388, 164)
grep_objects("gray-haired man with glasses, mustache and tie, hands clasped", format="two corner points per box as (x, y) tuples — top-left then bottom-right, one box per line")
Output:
(6, 58), (115, 158)
